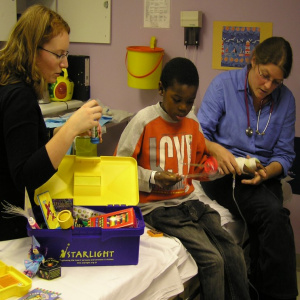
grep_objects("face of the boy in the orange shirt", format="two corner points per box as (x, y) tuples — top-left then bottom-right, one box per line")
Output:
(160, 81), (198, 121)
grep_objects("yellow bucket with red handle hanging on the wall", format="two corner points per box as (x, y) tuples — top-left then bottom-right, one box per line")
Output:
(125, 46), (164, 89)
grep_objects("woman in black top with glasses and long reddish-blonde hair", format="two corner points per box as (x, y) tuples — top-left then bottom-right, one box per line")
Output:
(0, 5), (102, 240)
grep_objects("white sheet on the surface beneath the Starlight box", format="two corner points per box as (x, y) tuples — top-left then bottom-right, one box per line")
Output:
(0, 229), (197, 300)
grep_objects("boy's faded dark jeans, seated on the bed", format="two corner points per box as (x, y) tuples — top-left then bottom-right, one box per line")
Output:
(144, 200), (250, 300)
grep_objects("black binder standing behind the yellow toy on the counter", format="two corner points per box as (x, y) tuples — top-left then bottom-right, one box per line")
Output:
(68, 55), (90, 101)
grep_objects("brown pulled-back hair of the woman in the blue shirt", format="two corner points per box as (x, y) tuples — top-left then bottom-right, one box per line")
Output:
(252, 36), (293, 78)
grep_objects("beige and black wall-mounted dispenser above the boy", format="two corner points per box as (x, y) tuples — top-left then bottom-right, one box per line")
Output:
(180, 11), (202, 47)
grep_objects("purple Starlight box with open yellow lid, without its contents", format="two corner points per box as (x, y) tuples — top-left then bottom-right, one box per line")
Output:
(28, 155), (145, 267)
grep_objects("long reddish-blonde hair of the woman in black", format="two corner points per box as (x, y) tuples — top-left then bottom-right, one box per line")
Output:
(0, 5), (70, 97)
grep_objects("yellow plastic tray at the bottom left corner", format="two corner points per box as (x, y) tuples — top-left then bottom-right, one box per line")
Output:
(0, 260), (32, 300)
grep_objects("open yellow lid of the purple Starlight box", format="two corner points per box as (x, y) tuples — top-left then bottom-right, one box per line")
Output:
(35, 155), (139, 206)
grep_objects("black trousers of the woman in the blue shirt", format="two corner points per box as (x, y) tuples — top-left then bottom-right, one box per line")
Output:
(201, 175), (298, 299)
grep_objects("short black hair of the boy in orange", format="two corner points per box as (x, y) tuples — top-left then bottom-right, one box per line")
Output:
(160, 57), (199, 90)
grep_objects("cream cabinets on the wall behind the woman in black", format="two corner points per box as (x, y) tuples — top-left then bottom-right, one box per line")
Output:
(0, 0), (111, 44)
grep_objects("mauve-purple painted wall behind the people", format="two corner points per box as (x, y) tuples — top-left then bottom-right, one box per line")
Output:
(70, 0), (300, 253)
